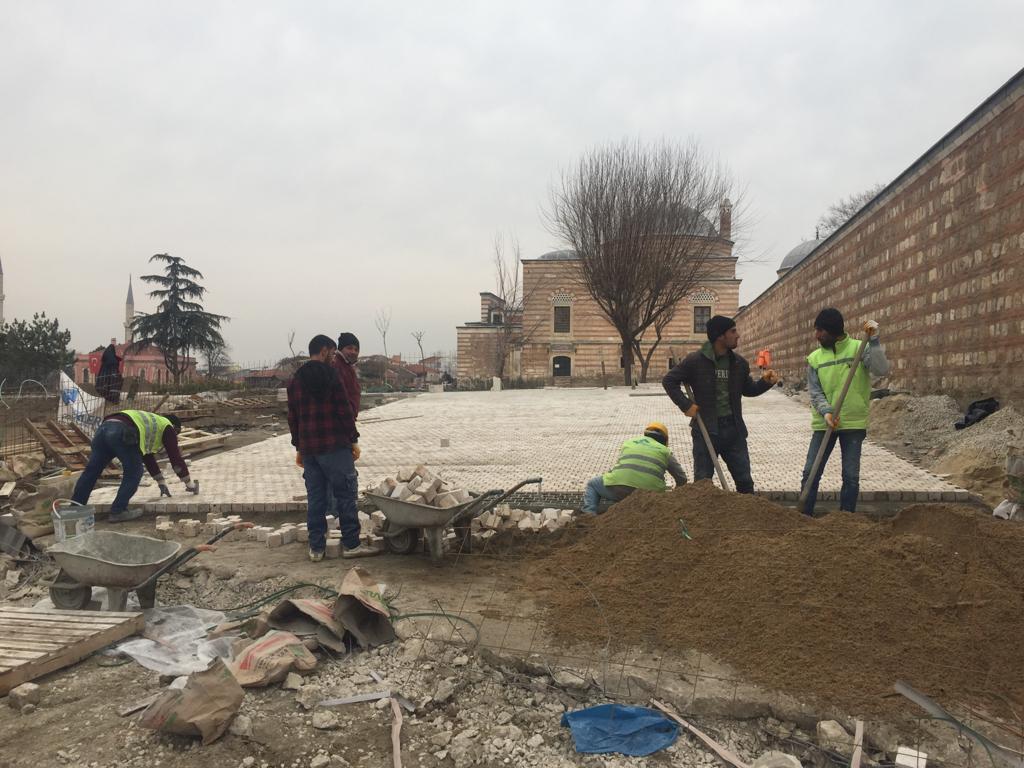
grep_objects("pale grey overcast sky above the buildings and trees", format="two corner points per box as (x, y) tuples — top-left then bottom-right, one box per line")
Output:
(0, 0), (1024, 361)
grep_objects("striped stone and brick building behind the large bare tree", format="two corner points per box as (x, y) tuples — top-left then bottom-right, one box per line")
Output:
(457, 205), (739, 384)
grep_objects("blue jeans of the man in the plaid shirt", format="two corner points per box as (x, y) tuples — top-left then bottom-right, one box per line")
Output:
(302, 445), (359, 552)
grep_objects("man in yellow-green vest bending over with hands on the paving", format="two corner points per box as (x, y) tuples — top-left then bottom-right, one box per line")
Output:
(72, 411), (199, 522)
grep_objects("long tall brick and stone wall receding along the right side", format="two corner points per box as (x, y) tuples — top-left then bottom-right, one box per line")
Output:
(737, 72), (1024, 403)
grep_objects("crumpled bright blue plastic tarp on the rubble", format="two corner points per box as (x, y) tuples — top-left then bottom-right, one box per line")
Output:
(562, 705), (679, 757)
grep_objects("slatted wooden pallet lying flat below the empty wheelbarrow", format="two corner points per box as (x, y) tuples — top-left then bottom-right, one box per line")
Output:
(0, 606), (145, 696)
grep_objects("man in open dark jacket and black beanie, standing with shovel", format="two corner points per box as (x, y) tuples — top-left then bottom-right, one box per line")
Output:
(662, 314), (778, 494)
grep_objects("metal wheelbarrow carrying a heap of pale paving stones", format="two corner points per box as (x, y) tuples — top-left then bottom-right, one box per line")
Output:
(364, 477), (542, 565)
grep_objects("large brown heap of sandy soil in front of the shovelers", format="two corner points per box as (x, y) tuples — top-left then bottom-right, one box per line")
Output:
(530, 482), (1024, 716)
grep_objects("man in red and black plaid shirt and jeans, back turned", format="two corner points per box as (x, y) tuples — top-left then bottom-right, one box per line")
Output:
(288, 335), (378, 562)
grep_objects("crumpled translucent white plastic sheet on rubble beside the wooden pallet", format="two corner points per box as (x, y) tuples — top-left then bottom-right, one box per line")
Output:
(117, 605), (236, 675)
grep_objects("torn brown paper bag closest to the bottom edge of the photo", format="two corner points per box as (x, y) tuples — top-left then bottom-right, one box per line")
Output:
(139, 658), (245, 744)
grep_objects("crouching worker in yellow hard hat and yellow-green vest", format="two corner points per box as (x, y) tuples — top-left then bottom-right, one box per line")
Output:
(583, 422), (686, 515)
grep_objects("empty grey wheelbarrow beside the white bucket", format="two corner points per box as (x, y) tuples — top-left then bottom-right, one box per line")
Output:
(48, 522), (253, 611)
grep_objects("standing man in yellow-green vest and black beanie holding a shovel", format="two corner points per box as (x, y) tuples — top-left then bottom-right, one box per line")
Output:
(800, 307), (889, 515)
